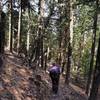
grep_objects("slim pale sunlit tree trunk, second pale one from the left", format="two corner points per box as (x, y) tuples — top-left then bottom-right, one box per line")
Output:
(17, 0), (22, 53)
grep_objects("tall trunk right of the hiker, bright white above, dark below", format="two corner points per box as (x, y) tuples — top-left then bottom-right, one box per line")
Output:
(65, 0), (73, 84)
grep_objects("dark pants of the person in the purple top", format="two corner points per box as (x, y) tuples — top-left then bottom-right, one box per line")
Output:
(50, 72), (60, 94)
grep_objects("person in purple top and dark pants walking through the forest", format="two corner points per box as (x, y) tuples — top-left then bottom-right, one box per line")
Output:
(49, 63), (60, 94)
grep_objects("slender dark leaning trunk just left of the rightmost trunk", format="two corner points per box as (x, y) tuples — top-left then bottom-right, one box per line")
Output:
(86, 0), (99, 95)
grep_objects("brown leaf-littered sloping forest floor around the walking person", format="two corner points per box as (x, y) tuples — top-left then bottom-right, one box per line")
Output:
(0, 54), (95, 100)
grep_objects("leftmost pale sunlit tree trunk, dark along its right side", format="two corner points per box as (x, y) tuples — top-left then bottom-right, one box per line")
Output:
(8, 0), (13, 52)
